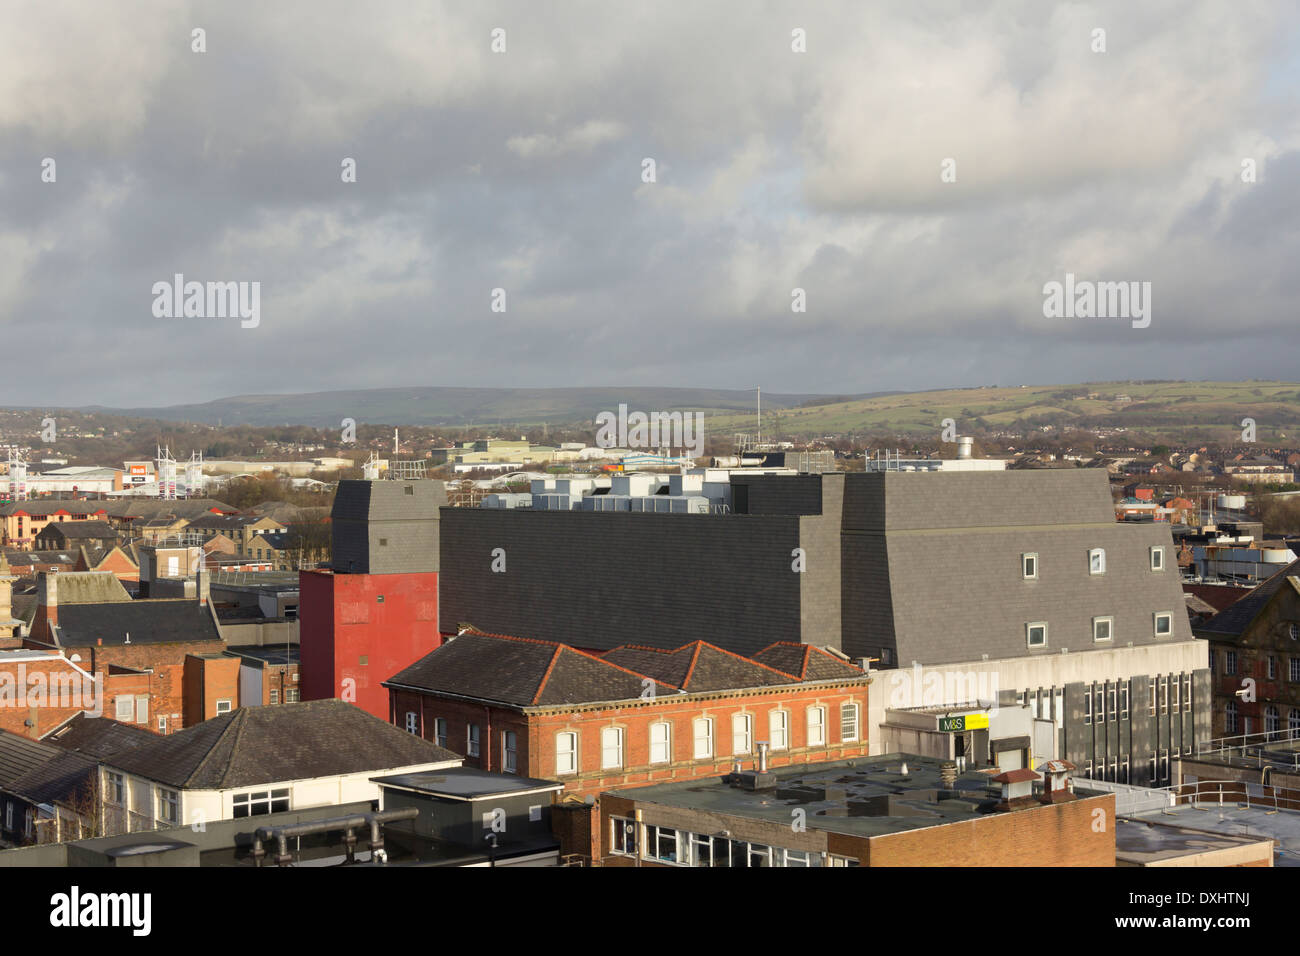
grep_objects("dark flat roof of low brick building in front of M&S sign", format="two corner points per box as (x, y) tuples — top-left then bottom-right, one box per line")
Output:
(606, 753), (1040, 836)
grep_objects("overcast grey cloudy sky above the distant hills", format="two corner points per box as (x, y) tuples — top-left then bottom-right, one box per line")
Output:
(0, 0), (1300, 406)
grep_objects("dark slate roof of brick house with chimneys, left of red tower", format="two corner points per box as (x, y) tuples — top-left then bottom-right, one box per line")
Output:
(57, 598), (221, 648)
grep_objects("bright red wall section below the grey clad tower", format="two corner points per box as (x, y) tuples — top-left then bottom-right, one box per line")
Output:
(298, 571), (442, 721)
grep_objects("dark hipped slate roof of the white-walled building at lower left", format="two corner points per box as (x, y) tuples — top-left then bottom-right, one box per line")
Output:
(104, 700), (462, 790)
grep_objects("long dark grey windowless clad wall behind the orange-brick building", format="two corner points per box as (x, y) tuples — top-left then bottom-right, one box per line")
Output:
(439, 507), (800, 653)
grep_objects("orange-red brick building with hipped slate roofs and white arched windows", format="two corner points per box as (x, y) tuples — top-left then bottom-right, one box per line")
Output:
(384, 632), (867, 796)
